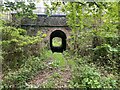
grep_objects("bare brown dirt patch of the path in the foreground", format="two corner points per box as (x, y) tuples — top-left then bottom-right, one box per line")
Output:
(28, 55), (72, 88)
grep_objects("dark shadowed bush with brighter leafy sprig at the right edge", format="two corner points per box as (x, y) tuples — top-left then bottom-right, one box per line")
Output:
(93, 36), (120, 73)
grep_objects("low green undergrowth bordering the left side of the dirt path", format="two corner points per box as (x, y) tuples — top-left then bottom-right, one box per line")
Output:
(2, 57), (45, 88)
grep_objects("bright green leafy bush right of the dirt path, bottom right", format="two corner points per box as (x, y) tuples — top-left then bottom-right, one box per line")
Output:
(70, 65), (117, 88)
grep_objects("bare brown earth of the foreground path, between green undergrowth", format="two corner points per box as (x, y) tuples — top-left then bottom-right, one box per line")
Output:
(29, 69), (71, 88)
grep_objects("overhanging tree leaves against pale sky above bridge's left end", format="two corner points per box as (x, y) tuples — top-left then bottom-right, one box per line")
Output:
(2, 1), (37, 27)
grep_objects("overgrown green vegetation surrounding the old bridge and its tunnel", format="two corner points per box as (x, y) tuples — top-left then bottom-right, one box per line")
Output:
(0, 2), (120, 89)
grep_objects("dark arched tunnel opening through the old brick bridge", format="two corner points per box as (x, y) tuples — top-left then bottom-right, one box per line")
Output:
(50, 30), (66, 53)
